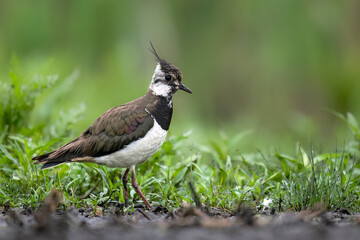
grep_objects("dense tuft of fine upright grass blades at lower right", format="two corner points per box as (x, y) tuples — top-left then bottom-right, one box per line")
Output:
(282, 148), (360, 211)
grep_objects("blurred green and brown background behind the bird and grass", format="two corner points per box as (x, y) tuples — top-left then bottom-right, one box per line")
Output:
(0, 0), (360, 151)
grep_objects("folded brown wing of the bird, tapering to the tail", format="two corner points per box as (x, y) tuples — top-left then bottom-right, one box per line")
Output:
(33, 105), (154, 168)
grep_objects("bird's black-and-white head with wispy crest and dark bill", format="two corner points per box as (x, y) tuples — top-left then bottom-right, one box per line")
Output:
(149, 42), (191, 98)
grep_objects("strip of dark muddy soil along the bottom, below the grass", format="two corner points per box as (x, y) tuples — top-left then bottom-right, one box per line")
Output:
(0, 202), (360, 240)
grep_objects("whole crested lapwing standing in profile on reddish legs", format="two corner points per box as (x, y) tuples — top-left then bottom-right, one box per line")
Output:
(33, 42), (191, 209)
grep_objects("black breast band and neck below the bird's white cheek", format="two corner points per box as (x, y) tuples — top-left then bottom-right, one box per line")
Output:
(145, 89), (173, 131)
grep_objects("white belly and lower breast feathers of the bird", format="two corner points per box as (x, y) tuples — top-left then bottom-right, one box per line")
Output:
(94, 120), (167, 168)
